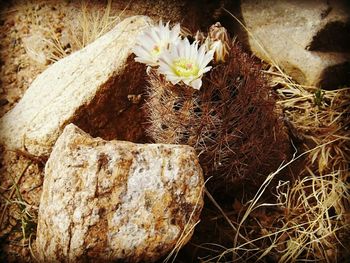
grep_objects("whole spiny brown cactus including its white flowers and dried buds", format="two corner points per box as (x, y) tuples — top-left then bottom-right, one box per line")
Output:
(134, 22), (289, 194)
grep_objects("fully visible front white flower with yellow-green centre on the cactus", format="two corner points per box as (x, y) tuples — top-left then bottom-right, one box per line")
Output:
(159, 38), (214, 89)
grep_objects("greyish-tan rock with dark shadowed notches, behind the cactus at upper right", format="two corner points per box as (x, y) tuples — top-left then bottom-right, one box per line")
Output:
(237, 0), (350, 89)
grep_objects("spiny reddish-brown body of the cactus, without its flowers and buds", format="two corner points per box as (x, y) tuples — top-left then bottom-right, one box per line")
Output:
(145, 42), (289, 193)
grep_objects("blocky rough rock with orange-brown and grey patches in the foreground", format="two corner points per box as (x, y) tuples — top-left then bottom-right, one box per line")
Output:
(36, 124), (204, 262)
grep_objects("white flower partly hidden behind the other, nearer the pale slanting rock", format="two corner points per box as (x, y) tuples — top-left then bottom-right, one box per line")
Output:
(133, 21), (180, 66)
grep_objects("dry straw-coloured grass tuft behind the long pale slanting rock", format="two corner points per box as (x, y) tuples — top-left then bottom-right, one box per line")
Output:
(14, 0), (131, 65)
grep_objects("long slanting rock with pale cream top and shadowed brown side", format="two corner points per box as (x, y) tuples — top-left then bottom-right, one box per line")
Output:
(0, 16), (152, 156)
